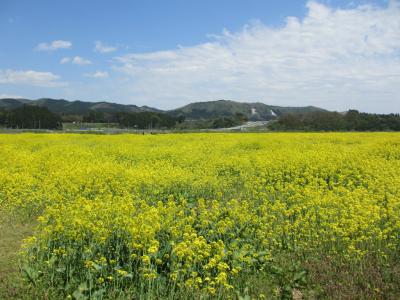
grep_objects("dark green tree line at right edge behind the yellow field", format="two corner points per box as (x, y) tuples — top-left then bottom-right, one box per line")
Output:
(270, 110), (400, 131)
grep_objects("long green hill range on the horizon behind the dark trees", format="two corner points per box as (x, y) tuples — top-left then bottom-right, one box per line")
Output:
(0, 98), (324, 120)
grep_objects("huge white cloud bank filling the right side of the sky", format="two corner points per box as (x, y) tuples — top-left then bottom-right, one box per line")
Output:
(113, 1), (400, 112)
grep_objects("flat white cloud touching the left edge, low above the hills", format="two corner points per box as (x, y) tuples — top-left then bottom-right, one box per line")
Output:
(0, 69), (66, 87)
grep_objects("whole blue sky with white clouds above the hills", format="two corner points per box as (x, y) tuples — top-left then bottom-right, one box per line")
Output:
(0, 0), (400, 112)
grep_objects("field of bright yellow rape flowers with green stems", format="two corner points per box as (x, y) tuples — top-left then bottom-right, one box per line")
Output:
(0, 133), (400, 299)
